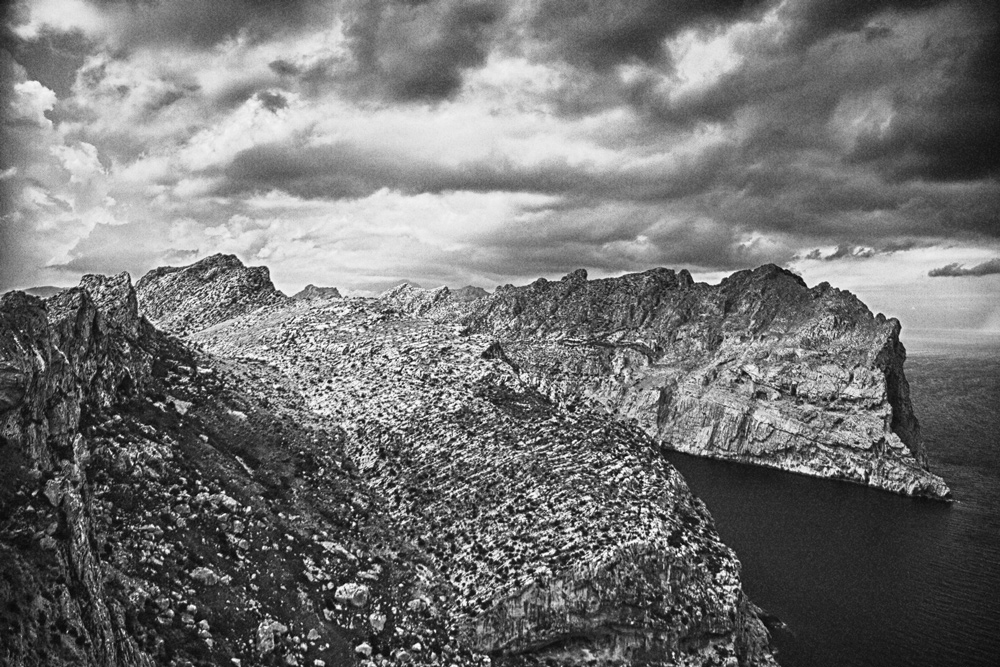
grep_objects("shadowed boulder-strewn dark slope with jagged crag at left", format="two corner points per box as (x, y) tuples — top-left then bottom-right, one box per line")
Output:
(0, 272), (508, 667)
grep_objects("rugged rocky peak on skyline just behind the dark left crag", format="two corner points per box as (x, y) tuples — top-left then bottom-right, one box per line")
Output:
(135, 254), (287, 334)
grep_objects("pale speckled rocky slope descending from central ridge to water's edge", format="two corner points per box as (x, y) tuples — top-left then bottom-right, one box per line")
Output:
(194, 287), (773, 666)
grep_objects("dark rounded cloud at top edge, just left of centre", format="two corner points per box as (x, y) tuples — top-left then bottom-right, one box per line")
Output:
(345, 0), (507, 101)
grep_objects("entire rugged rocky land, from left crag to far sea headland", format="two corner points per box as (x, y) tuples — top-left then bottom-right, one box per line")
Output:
(0, 255), (949, 667)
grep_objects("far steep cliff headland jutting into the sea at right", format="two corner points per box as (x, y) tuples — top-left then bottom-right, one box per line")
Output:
(452, 265), (950, 498)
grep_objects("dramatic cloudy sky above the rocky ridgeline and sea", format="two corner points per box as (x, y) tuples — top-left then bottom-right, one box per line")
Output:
(0, 0), (1000, 330)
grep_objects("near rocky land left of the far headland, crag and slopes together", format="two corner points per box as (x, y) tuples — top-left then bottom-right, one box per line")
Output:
(0, 256), (774, 667)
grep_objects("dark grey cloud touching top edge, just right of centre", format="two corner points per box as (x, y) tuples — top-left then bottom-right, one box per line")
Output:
(532, 0), (770, 69)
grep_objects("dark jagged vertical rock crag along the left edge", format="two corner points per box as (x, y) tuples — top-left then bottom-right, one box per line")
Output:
(0, 274), (157, 665)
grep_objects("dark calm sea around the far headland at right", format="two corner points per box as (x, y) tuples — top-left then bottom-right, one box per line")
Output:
(669, 332), (1000, 667)
